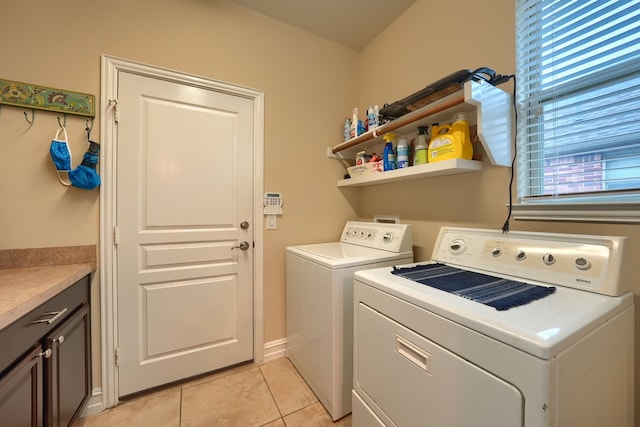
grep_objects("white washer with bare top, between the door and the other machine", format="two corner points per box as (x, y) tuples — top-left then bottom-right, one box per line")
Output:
(286, 221), (413, 420)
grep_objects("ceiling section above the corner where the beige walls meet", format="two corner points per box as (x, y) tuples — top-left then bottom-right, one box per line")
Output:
(230, 0), (415, 51)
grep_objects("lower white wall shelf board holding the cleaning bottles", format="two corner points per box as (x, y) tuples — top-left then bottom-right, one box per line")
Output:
(338, 159), (483, 187)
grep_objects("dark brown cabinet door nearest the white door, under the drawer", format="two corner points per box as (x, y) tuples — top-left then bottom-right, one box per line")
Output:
(45, 304), (91, 427)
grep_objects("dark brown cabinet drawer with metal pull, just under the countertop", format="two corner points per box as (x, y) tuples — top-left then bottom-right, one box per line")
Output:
(0, 276), (89, 376)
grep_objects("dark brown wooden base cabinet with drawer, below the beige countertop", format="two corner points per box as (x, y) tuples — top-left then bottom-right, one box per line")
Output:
(0, 276), (91, 427)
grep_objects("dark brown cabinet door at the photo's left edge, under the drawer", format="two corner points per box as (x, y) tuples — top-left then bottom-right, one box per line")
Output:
(0, 345), (44, 427)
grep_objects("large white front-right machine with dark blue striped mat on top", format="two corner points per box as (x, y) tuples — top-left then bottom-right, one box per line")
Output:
(352, 227), (634, 427)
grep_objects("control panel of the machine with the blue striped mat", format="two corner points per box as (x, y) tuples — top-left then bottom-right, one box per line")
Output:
(433, 227), (627, 295)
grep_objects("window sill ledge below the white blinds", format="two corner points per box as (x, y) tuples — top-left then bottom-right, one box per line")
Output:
(512, 203), (640, 223)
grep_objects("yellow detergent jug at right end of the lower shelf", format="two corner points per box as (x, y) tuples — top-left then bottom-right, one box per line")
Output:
(429, 113), (473, 163)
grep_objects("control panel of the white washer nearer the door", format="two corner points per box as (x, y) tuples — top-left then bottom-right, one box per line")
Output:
(340, 221), (413, 252)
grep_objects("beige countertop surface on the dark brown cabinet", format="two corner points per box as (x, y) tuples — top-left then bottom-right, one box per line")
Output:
(0, 263), (96, 329)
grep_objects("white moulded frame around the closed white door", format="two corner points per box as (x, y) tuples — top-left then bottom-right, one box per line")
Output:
(97, 55), (264, 413)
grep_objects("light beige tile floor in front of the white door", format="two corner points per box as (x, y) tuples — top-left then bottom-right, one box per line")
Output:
(74, 357), (351, 427)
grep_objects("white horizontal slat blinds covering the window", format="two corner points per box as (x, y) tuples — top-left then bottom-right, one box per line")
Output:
(516, 0), (640, 203)
